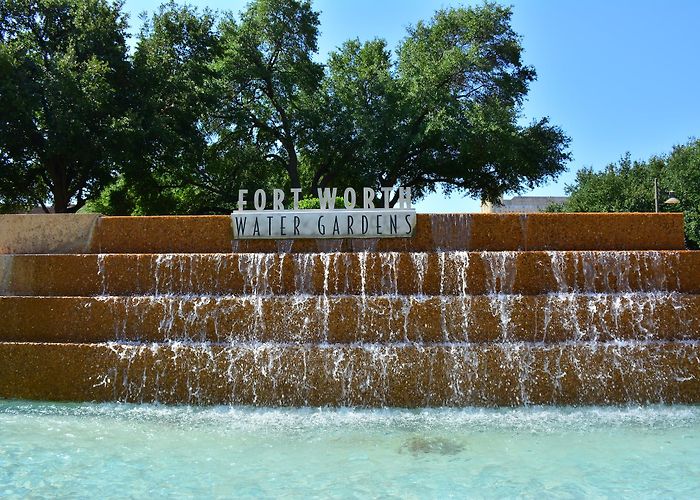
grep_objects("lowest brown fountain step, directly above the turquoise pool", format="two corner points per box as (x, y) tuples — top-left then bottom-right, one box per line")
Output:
(0, 342), (700, 407)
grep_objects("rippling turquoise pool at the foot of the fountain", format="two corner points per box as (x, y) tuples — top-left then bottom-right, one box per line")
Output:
(0, 401), (700, 498)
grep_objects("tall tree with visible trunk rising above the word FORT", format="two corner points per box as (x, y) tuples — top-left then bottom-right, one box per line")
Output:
(216, 0), (323, 187)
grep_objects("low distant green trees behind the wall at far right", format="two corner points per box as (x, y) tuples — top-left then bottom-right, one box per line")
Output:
(549, 140), (700, 248)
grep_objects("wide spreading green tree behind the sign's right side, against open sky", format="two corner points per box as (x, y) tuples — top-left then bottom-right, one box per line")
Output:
(306, 4), (569, 201)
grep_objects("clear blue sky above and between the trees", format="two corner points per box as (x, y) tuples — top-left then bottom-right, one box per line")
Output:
(124, 0), (700, 212)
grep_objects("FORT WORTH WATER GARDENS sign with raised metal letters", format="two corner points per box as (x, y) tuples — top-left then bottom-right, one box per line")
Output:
(231, 187), (416, 239)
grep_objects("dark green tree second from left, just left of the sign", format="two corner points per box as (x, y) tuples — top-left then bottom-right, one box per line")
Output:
(115, 2), (221, 214)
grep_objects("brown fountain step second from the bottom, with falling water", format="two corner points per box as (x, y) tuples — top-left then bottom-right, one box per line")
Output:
(0, 293), (700, 344)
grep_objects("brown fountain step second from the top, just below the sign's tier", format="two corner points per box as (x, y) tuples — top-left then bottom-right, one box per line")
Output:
(0, 250), (700, 296)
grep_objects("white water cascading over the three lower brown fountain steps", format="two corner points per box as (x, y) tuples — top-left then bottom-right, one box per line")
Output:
(52, 247), (699, 406)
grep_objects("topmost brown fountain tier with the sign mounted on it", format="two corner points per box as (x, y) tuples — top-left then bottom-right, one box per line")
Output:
(0, 213), (685, 254)
